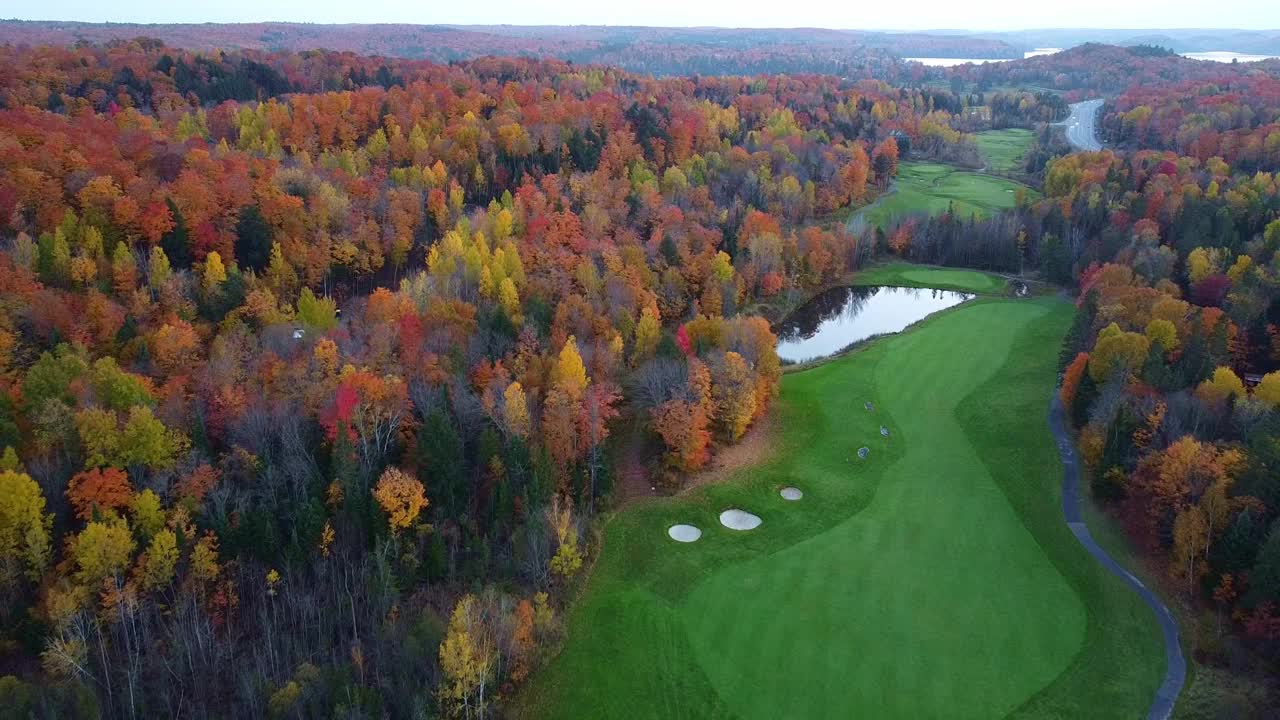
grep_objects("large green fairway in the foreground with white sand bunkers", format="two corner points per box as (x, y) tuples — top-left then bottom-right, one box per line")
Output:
(515, 266), (1164, 719)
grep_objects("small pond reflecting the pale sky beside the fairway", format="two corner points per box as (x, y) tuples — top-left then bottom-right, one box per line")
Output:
(778, 287), (973, 363)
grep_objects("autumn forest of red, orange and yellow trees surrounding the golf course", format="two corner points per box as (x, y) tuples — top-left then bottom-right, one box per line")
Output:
(0, 20), (1280, 717)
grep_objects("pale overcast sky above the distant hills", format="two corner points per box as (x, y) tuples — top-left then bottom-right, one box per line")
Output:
(0, 0), (1280, 31)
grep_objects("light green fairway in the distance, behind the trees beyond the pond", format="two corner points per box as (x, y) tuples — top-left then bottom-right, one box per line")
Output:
(850, 161), (1038, 231)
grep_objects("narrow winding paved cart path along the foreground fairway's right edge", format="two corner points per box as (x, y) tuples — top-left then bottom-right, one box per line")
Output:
(1048, 391), (1187, 720)
